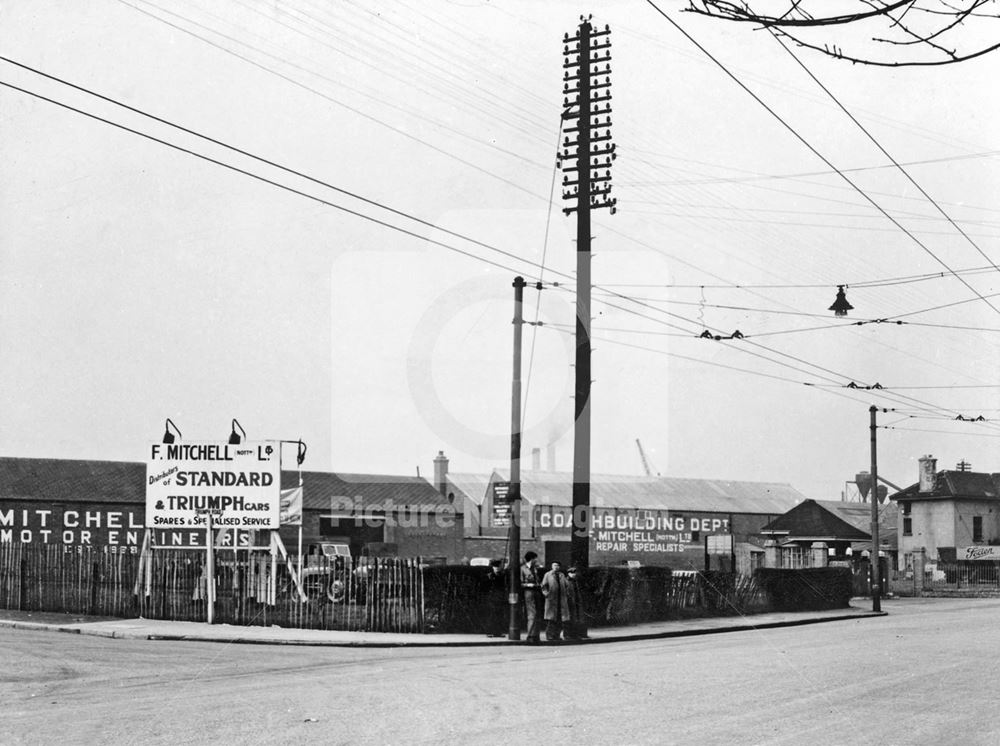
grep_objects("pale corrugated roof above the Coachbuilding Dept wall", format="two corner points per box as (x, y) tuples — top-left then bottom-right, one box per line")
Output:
(476, 470), (806, 514)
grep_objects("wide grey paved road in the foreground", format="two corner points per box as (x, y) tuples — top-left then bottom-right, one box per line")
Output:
(0, 599), (1000, 746)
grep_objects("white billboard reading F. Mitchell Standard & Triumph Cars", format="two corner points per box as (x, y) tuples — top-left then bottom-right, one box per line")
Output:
(146, 441), (281, 529)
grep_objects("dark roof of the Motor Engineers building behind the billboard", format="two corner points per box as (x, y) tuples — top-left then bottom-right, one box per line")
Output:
(0, 457), (451, 509)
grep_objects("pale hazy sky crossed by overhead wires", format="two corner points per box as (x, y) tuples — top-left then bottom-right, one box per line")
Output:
(0, 0), (1000, 499)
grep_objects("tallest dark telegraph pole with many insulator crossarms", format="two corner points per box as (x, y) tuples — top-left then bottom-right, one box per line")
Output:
(559, 16), (617, 568)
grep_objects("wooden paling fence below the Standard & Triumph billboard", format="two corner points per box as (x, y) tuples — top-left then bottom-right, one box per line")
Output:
(0, 543), (424, 632)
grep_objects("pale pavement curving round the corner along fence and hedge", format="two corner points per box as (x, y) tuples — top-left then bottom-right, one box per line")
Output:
(0, 599), (886, 648)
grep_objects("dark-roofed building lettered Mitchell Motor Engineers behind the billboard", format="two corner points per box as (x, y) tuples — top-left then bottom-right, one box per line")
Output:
(0, 457), (463, 562)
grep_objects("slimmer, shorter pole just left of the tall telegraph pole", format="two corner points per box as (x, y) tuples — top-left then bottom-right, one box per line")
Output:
(507, 277), (525, 640)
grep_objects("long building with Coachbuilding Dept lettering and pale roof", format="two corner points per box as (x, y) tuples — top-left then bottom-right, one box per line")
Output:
(435, 454), (805, 570)
